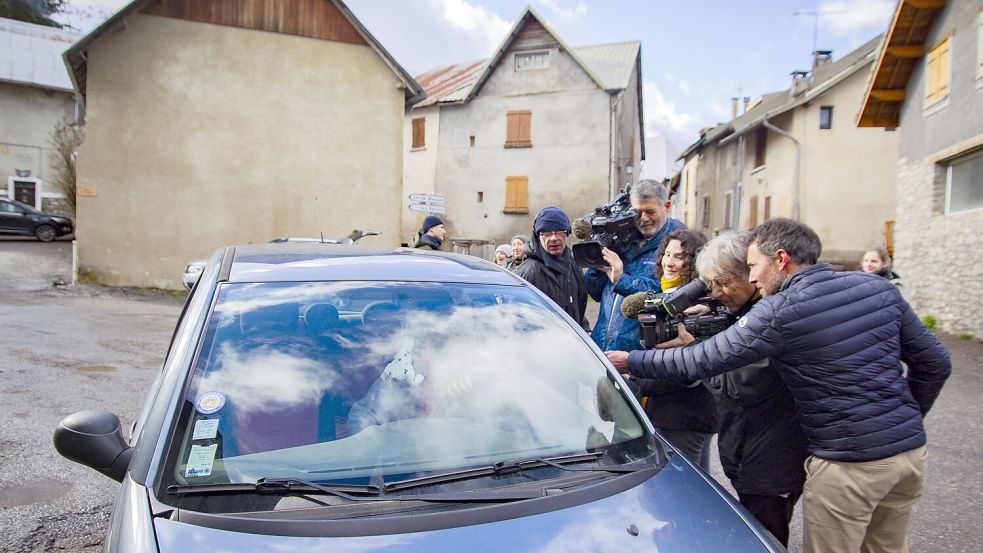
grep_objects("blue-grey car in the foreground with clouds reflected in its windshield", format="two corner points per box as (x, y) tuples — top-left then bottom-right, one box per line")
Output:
(54, 243), (784, 553)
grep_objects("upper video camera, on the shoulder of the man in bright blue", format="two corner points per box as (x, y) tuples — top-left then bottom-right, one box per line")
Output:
(571, 184), (638, 267)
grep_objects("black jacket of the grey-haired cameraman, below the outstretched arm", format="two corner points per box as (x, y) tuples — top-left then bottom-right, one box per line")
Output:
(703, 299), (808, 495)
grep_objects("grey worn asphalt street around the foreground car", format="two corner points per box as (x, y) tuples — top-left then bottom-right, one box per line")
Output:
(0, 239), (983, 553)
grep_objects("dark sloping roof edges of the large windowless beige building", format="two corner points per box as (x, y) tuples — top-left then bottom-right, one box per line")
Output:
(63, 0), (423, 103)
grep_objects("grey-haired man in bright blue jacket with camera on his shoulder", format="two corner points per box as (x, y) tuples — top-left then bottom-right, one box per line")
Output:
(584, 180), (686, 350)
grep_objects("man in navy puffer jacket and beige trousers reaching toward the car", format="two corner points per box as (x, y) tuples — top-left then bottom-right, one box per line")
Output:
(608, 219), (951, 553)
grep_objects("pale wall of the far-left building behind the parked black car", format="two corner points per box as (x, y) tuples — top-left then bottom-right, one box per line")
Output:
(0, 83), (75, 210)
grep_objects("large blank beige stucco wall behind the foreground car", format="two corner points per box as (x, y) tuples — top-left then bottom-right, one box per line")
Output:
(78, 15), (404, 288)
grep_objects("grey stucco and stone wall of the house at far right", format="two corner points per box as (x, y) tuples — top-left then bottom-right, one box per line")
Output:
(894, 2), (983, 339)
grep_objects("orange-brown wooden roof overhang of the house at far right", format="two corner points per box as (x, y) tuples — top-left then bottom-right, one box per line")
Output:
(857, 0), (945, 127)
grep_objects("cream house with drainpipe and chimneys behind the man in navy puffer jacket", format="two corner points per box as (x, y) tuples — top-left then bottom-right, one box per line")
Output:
(676, 37), (897, 268)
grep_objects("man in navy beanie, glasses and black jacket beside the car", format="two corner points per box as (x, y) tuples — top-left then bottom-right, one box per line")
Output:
(515, 205), (589, 331)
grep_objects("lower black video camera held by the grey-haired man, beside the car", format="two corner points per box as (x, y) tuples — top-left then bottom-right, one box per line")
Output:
(638, 279), (731, 349)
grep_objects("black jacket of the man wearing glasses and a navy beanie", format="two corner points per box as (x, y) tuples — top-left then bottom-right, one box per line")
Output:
(515, 238), (590, 332)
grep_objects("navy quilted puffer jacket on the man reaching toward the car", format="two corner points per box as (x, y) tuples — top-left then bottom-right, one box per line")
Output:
(628, 263), (951, 462)
